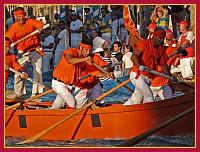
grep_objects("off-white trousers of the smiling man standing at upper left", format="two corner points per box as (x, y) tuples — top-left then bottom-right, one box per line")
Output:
(14, 51), (43, 96)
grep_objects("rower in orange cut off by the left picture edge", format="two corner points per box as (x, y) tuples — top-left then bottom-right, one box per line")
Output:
(5, 41), (28, 88)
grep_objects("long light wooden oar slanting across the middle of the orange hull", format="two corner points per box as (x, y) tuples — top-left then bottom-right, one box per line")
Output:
(19, 79), (131, 144)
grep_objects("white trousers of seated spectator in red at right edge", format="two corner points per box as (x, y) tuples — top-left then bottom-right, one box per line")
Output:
(180, 57), (194, 78)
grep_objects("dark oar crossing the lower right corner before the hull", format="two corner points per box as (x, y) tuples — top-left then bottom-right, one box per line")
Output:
(117, 107), (195, 147)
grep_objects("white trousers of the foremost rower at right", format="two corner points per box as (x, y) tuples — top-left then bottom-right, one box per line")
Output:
(125, 72), (154, 105)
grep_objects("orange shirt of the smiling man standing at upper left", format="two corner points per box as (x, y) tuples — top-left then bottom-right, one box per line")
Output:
(5, 18), (44, 52)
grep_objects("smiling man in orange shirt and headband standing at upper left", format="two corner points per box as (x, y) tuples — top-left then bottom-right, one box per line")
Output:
(5, 7), (44, 98)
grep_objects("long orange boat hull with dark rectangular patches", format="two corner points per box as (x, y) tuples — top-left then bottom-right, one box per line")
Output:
(5, 83), (195, 140)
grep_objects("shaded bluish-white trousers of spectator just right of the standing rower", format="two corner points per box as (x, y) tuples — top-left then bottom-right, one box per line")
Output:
(42, 52), (53, 72)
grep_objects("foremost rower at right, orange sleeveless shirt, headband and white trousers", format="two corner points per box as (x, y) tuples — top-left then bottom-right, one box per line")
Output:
(124, 27), (171, 105)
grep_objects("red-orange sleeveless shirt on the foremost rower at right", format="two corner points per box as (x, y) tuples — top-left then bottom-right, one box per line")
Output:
(131, 40), (168, 78)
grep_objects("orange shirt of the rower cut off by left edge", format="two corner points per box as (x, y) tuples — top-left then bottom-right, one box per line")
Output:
(5, 53), (21, 84)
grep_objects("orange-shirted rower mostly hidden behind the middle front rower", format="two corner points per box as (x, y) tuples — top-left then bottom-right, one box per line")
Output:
(75, 53), (114, 107)
